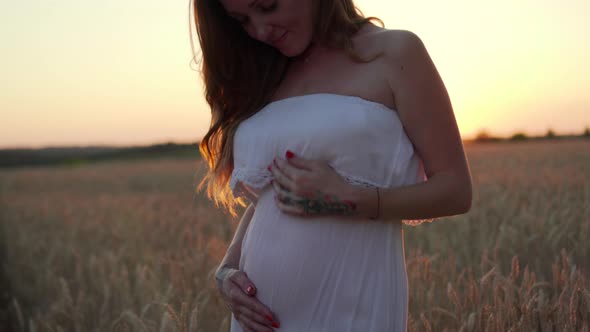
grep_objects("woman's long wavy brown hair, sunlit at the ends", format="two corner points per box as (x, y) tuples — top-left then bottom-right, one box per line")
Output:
(189, 0), (383, 217)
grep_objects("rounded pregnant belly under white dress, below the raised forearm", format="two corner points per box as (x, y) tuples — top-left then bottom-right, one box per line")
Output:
(240, 190), (405, 325)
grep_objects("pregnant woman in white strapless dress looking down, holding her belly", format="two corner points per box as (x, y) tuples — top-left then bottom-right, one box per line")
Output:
(194, 0), (472, 332)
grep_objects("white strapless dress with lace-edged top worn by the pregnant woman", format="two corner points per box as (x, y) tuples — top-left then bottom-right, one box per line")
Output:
(230, 93), (432, 332)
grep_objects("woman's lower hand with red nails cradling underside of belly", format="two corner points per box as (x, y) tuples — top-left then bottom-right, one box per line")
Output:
(216, 267), (279, 332)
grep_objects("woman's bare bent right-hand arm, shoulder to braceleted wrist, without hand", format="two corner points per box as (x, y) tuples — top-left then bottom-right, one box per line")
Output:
(352, 31), (472, 220)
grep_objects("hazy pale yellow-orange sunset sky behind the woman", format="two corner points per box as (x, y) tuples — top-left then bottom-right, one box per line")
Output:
(0, 0), (590, 147)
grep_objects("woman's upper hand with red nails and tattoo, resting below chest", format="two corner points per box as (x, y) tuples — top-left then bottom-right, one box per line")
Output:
(269, 150), (358, 216)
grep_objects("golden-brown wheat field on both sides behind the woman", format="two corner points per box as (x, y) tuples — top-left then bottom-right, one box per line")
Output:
(0, 140), (590, 332)
